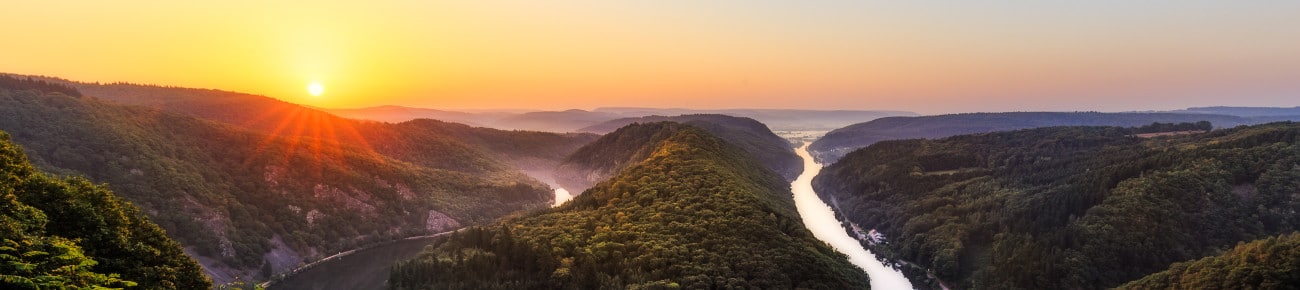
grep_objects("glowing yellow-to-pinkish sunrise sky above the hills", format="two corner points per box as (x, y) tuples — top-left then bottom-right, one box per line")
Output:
(0, 0), (1300, 113)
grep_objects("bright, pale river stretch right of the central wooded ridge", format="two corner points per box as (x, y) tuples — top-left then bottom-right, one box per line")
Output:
(790, 142), (914, 290)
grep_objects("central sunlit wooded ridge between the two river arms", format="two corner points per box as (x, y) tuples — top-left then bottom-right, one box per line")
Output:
(389, 122), (868, 289)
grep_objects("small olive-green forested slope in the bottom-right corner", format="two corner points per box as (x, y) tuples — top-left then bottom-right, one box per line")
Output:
(1119, 233), (1300, 289)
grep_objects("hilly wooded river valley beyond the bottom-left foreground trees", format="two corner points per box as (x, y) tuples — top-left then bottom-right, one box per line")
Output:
(0, 75), (1300, 289)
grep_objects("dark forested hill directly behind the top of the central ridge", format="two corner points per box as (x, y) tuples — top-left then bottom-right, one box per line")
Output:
(555, 114), (803, 191)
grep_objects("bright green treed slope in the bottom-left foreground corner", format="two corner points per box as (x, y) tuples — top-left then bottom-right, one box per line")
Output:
(0, 131), (212, 289)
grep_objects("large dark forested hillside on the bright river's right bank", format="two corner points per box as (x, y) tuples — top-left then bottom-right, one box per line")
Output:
(814, 122), (1300, 289)
